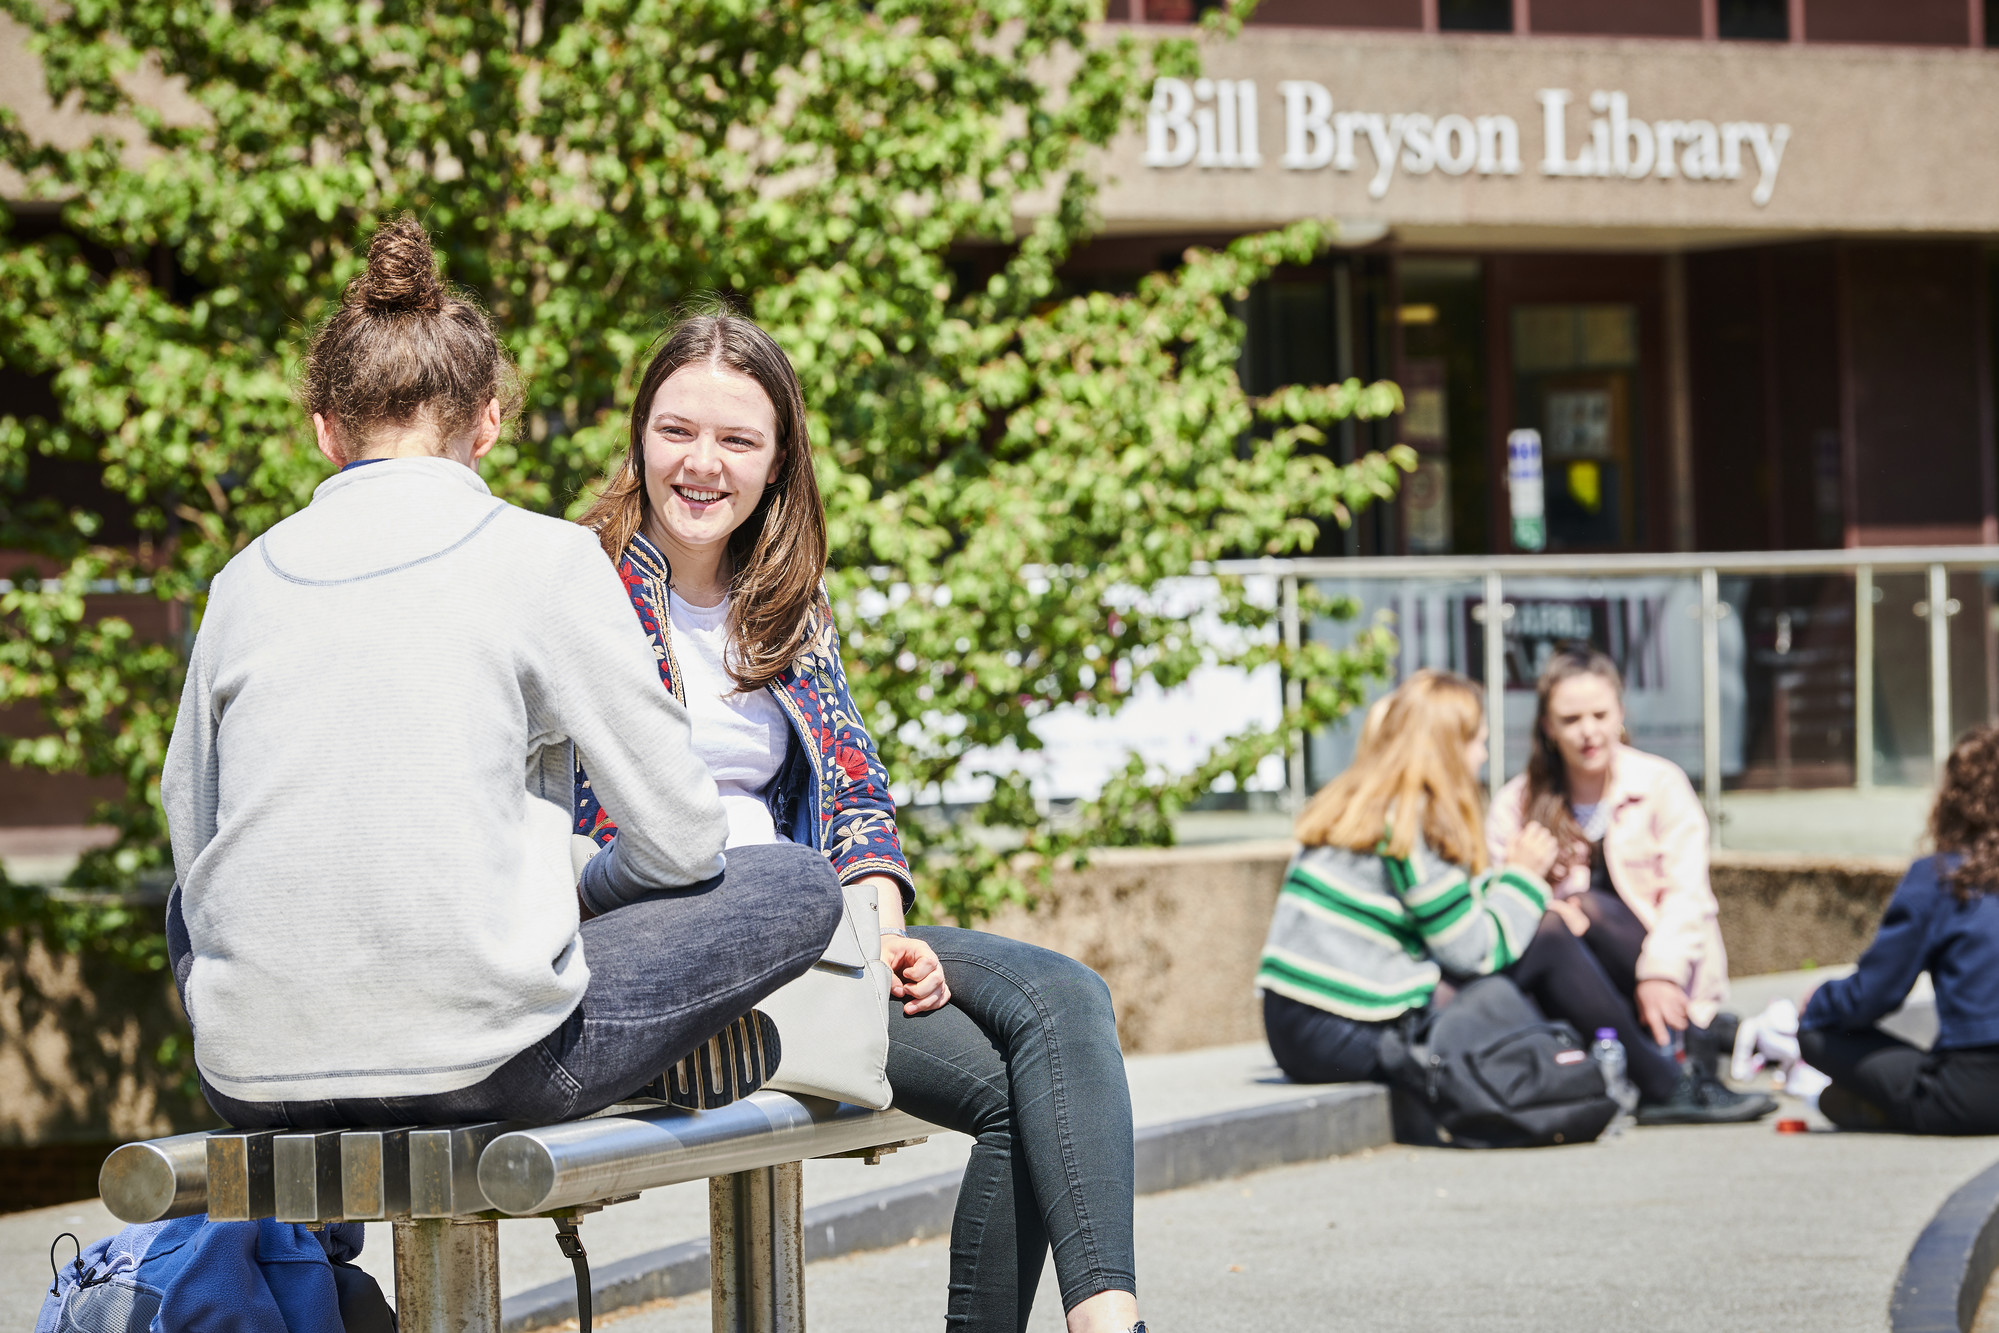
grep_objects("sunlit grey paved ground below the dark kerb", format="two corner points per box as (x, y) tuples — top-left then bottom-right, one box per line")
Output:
(604, 1123), (1999, 1333)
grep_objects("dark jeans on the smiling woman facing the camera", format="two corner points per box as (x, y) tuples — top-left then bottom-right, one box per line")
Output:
(888, 925), (1137, 1333)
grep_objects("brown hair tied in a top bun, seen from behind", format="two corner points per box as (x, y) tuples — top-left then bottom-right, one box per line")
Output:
(300, 214), (520, 453)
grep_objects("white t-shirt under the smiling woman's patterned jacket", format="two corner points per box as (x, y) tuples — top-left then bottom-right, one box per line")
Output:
(666, 592), (792, 847)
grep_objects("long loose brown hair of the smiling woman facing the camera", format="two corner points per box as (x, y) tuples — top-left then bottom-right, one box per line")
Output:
(582, 312), (830, 691)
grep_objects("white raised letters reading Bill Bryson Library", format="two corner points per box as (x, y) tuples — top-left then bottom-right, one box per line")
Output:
(1143, 78), (1791, 208)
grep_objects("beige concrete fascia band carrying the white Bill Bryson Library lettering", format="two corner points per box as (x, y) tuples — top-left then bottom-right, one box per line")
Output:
(1099, 29), (1999, 239)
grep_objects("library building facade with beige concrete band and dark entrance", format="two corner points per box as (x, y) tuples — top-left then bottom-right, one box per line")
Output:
(1079, 0), (1999, 554)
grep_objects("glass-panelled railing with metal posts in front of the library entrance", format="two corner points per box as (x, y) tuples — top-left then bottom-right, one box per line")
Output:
(1215, 546), (1999, 855)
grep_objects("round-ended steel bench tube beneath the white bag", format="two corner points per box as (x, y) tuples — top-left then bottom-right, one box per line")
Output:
(478, 1091), (934, 1217)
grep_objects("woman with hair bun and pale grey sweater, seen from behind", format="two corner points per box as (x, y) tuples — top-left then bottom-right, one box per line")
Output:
(160, 218), (842, 1129)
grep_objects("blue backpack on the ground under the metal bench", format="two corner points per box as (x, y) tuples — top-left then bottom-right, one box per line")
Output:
(34, 1215), (396, 1333)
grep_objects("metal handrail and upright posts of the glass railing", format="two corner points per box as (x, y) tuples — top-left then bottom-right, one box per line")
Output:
(1193, 546), (1999, 849)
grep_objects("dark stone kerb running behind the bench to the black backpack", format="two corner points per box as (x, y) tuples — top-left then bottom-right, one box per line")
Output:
(500, 1083), (1391, 1333)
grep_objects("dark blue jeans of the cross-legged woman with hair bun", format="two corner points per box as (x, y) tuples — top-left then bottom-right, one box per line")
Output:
(166, 843), (842, 1129)
